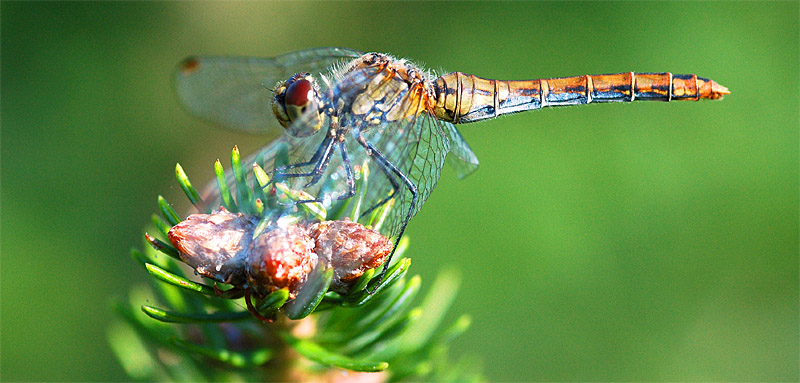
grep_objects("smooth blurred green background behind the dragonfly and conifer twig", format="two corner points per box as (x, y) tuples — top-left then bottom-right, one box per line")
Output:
(0, 1), (800, 381)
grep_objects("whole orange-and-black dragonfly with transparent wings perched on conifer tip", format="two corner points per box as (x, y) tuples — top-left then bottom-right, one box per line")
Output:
(174, 48), (730, 282)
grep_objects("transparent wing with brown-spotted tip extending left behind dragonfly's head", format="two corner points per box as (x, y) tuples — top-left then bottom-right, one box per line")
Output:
(174, 48), (361, 133)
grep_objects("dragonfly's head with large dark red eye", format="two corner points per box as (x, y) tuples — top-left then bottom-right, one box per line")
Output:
(272, 73), (322, 137)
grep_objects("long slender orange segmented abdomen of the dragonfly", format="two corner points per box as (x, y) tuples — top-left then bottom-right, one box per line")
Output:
(434, 72), (730, 123)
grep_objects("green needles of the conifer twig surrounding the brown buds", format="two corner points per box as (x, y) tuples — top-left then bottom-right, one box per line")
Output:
(109, 145), (480, 381)
